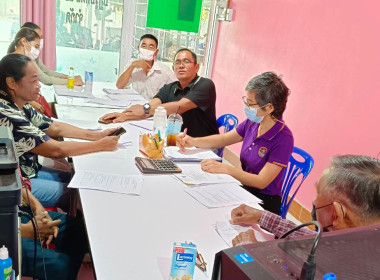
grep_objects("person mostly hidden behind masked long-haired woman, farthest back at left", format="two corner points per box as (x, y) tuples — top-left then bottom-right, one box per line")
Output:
(21, 22), (83, 86)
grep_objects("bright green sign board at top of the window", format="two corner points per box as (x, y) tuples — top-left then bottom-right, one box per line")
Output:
(146, 0), (202, 33)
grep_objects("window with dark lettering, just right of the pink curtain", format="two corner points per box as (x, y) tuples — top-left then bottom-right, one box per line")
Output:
(56, 0), (124, 82)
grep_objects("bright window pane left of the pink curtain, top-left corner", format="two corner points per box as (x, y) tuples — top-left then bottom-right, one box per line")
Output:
(0, 0), (20, 57)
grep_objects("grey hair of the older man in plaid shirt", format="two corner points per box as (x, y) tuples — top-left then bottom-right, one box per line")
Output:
(322, 155), (380, 223)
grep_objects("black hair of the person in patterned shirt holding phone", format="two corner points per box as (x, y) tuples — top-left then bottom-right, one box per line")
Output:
(0, 53), (32, 93)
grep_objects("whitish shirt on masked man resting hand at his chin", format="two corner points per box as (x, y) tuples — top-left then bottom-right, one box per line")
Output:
(125, 60), (177, 101)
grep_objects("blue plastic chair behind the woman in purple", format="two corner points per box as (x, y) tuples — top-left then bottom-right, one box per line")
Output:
(281, 147), (314, 219)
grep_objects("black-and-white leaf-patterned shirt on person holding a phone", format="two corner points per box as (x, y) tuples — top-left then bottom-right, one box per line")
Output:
(0, 91), (52, 178)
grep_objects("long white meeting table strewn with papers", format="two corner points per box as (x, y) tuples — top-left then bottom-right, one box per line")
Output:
(56, 100), (262, 280)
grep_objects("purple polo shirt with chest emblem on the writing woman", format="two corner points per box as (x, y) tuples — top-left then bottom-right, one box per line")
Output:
(236, 119), (294, 196)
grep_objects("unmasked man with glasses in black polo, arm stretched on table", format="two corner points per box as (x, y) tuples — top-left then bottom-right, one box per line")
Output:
(101, 49), (219, 137)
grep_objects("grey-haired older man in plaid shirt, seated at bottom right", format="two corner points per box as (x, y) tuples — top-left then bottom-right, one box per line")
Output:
(231, 155), (380, 246)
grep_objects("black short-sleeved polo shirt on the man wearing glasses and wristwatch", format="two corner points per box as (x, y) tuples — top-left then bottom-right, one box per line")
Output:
(155, 76), (219, 137)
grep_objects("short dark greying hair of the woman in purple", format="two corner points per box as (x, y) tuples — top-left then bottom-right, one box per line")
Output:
(245, 72), (290, 119)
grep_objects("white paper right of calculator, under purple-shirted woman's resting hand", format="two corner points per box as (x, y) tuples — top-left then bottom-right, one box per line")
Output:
(173, 164), (239, 185)
